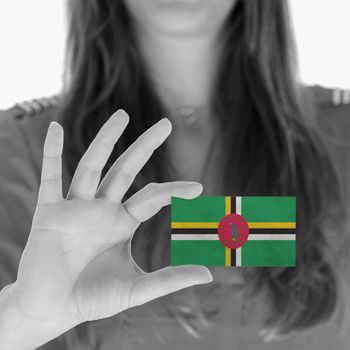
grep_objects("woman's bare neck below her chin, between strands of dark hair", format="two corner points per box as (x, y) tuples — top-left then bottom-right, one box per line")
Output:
(138, 30), (218, 115)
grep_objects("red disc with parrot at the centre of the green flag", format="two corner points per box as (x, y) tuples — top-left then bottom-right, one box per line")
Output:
(218, 213), (249, 249)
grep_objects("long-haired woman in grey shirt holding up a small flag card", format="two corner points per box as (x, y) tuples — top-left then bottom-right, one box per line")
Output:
(0, 0), (348, 349)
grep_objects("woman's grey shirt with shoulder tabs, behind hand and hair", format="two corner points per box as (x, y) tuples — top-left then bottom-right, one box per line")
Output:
(0, 86), (350, 350)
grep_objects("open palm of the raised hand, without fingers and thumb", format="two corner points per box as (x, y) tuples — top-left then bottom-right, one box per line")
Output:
(19, 199), (138, 320)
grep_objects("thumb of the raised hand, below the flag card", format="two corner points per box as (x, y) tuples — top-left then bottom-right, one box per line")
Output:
(130, 265), (213, 307)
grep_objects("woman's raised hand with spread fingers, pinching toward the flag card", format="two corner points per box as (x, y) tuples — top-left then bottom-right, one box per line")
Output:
(0, 111), (212, 348)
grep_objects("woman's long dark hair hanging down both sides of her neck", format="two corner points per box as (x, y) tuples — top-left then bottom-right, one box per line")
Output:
(59, 0), (348, 344)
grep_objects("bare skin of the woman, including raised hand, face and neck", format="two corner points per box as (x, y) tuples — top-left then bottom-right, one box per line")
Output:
(0, 0), (241, 350)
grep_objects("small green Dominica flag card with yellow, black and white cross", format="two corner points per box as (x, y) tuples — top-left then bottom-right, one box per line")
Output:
(171, 196), (296, 266)
